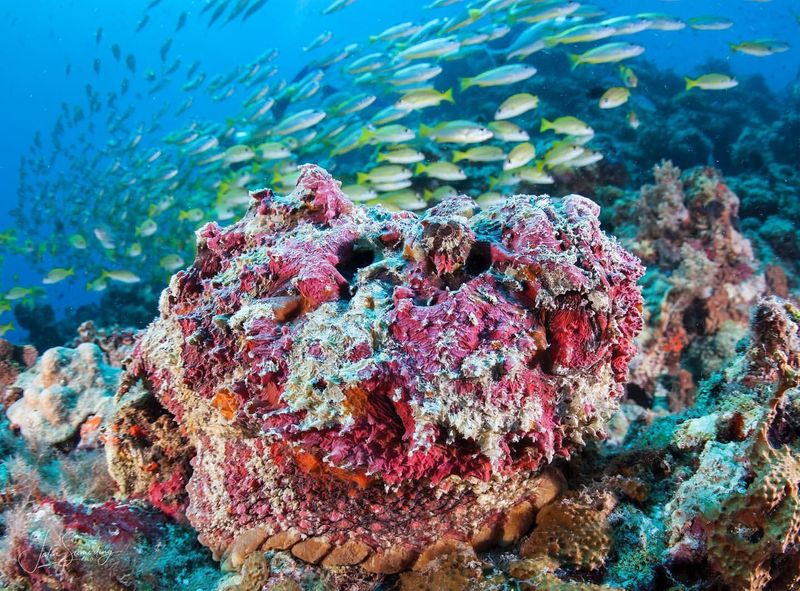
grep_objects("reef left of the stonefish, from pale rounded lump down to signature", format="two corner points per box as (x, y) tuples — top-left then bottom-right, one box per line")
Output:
(0, 346), (220, 591)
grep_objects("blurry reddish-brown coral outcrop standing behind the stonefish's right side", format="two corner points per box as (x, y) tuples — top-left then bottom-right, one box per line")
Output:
(628, 162), (766, 410)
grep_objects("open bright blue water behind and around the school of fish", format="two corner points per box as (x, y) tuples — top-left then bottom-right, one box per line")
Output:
(0, 0), (800, 340)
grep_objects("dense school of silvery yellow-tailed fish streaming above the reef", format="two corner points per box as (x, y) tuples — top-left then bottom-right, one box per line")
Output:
(0, 0), (790, 332)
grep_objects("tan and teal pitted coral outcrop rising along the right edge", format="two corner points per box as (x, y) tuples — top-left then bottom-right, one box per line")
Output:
(665, 299), (800, 591)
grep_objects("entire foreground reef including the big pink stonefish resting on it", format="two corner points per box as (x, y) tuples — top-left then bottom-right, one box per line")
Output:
(0, 163), (800, 591)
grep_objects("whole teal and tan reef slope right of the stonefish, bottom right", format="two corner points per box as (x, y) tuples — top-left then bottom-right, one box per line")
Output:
(378, 298), (800, 591)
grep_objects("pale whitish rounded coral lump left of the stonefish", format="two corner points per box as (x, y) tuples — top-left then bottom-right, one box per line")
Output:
(6, 343), (121, 447)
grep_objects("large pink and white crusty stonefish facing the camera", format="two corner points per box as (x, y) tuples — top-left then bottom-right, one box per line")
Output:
(123, 166), (642, 572)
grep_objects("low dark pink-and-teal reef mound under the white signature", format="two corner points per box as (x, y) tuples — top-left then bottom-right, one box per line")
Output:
(0, 498), (215, 591)
